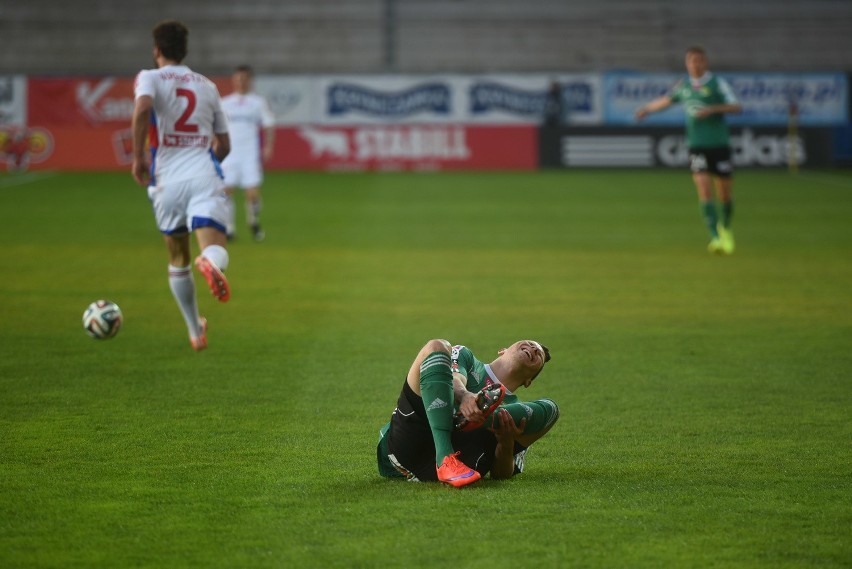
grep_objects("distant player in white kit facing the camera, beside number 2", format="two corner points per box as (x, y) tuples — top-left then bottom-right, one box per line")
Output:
(222, 65), (275, 241)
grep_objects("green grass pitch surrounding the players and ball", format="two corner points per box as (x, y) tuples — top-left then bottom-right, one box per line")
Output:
(0, 171), (852, 569)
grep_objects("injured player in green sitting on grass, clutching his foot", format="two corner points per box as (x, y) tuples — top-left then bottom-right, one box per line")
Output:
(376, 340), (559, 487)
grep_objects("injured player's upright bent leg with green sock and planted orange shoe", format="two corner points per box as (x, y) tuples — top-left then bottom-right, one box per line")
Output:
(406, 340), (479, 486)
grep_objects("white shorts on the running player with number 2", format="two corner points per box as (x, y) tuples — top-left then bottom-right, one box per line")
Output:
(148, 176), (228, 235)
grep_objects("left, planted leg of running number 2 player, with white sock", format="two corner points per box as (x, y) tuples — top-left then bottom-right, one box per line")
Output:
(164, 232), (207, 351)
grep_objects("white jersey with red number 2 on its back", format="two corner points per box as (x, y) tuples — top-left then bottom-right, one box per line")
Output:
(134, 65), (228, 185)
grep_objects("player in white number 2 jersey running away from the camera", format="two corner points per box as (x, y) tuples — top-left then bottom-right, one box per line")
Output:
(132, 20), (231, 351)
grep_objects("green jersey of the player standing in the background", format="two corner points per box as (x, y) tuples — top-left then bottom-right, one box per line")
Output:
(668, 71), (737, 148)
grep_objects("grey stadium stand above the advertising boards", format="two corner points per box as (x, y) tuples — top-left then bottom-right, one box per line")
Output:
(0, 0), (852, 75)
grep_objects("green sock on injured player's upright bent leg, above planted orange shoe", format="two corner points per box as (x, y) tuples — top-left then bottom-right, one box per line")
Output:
(420, 352), (454, 465)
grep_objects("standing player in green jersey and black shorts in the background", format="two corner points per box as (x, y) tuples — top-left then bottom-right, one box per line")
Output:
(636, 47), (742, 255)
